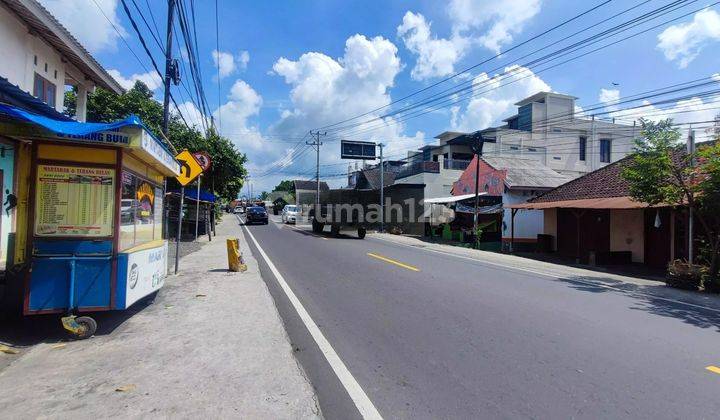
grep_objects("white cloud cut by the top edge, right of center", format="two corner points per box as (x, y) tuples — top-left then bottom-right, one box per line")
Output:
(448, 0), (541, 53)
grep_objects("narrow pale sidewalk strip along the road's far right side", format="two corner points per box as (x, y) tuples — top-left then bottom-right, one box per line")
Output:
(368, 233), (720, 312)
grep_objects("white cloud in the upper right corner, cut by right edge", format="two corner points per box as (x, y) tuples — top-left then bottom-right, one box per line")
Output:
(657, 9), (720, 69)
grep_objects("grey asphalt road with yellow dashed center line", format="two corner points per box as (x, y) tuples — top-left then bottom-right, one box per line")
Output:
(240, 215), (720, 419)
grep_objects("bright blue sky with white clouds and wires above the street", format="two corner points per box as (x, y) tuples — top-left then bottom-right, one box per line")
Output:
(42, 0), (720, 191)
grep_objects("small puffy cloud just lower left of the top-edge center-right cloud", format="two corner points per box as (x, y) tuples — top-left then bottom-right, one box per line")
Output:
(397, 12), (467, 80)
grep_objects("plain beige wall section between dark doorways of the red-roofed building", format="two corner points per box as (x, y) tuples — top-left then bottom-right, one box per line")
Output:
(610, 210), (645, 263)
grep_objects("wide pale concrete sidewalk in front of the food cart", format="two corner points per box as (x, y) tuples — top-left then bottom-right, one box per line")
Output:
(0, 217), (320, 419)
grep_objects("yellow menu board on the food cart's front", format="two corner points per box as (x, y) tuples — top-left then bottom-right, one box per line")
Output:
(35, 165), (115, 237)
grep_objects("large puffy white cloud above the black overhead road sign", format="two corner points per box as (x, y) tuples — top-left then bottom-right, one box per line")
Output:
(259, 35), (425, 188)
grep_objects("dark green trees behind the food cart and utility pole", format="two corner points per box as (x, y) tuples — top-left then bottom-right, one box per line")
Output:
(65, 81), (247, 201)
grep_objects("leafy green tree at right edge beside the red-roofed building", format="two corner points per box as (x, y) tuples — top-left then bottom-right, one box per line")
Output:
(622, 120), (720, 290)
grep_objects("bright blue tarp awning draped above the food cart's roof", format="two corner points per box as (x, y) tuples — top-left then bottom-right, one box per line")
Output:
(0, 104), (147, 136)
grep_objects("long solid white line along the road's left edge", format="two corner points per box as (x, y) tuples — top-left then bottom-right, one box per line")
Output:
(244, 226), (382, 419)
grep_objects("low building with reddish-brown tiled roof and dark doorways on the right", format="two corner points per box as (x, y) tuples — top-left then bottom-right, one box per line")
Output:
(506, 158), (688, 268)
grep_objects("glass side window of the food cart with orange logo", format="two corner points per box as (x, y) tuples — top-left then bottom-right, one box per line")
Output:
(120, 171), (162, 250)
